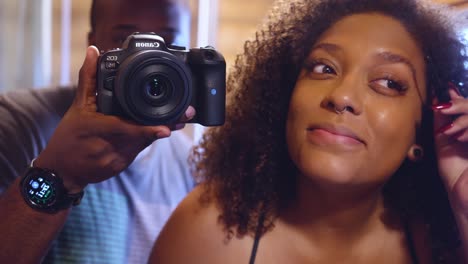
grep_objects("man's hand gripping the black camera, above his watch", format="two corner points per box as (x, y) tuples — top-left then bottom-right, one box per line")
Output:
(35, 46), (195, 193)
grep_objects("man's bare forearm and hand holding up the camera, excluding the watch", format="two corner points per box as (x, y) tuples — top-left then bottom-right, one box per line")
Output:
(0, 47), (194, 263)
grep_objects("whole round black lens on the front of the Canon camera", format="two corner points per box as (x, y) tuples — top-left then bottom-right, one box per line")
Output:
(115, 50), (193, 125)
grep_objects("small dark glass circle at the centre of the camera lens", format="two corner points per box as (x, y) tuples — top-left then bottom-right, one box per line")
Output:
(141, 74), (173, 105)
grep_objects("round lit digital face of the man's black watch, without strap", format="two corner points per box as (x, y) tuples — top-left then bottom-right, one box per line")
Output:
(22, 169), (58, 208)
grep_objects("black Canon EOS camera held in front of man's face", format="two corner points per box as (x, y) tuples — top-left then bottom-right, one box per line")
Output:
(97, 32), (226, 126)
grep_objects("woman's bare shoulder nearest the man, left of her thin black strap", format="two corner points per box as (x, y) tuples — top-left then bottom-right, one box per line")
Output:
(150, 184), (251, 263)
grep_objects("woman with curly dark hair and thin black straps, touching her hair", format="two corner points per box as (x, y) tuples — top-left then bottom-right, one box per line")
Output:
(151, 0), (468, 263)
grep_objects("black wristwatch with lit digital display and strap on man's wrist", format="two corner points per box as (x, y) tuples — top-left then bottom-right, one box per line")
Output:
(20, 163), (84, 214)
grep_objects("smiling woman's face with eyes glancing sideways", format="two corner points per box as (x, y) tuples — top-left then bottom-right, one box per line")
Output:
(286, 13), (426, 186)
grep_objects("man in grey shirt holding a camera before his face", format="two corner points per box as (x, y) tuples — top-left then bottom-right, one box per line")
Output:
(0, 0), (195, 263)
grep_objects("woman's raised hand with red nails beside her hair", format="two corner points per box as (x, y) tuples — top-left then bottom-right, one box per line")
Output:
(434, 88), (468, 214)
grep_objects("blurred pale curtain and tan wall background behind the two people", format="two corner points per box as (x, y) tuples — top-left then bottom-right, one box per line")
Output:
(0, 0), (468, 91)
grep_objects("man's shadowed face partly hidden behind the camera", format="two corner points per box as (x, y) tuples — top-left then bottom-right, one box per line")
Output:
(88, 0), (190, 51)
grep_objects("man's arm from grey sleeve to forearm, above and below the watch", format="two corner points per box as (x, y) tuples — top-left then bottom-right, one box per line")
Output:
(0, 80), (75, 263)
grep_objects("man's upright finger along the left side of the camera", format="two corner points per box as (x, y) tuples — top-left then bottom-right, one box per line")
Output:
(75, 46), (99, 106)
